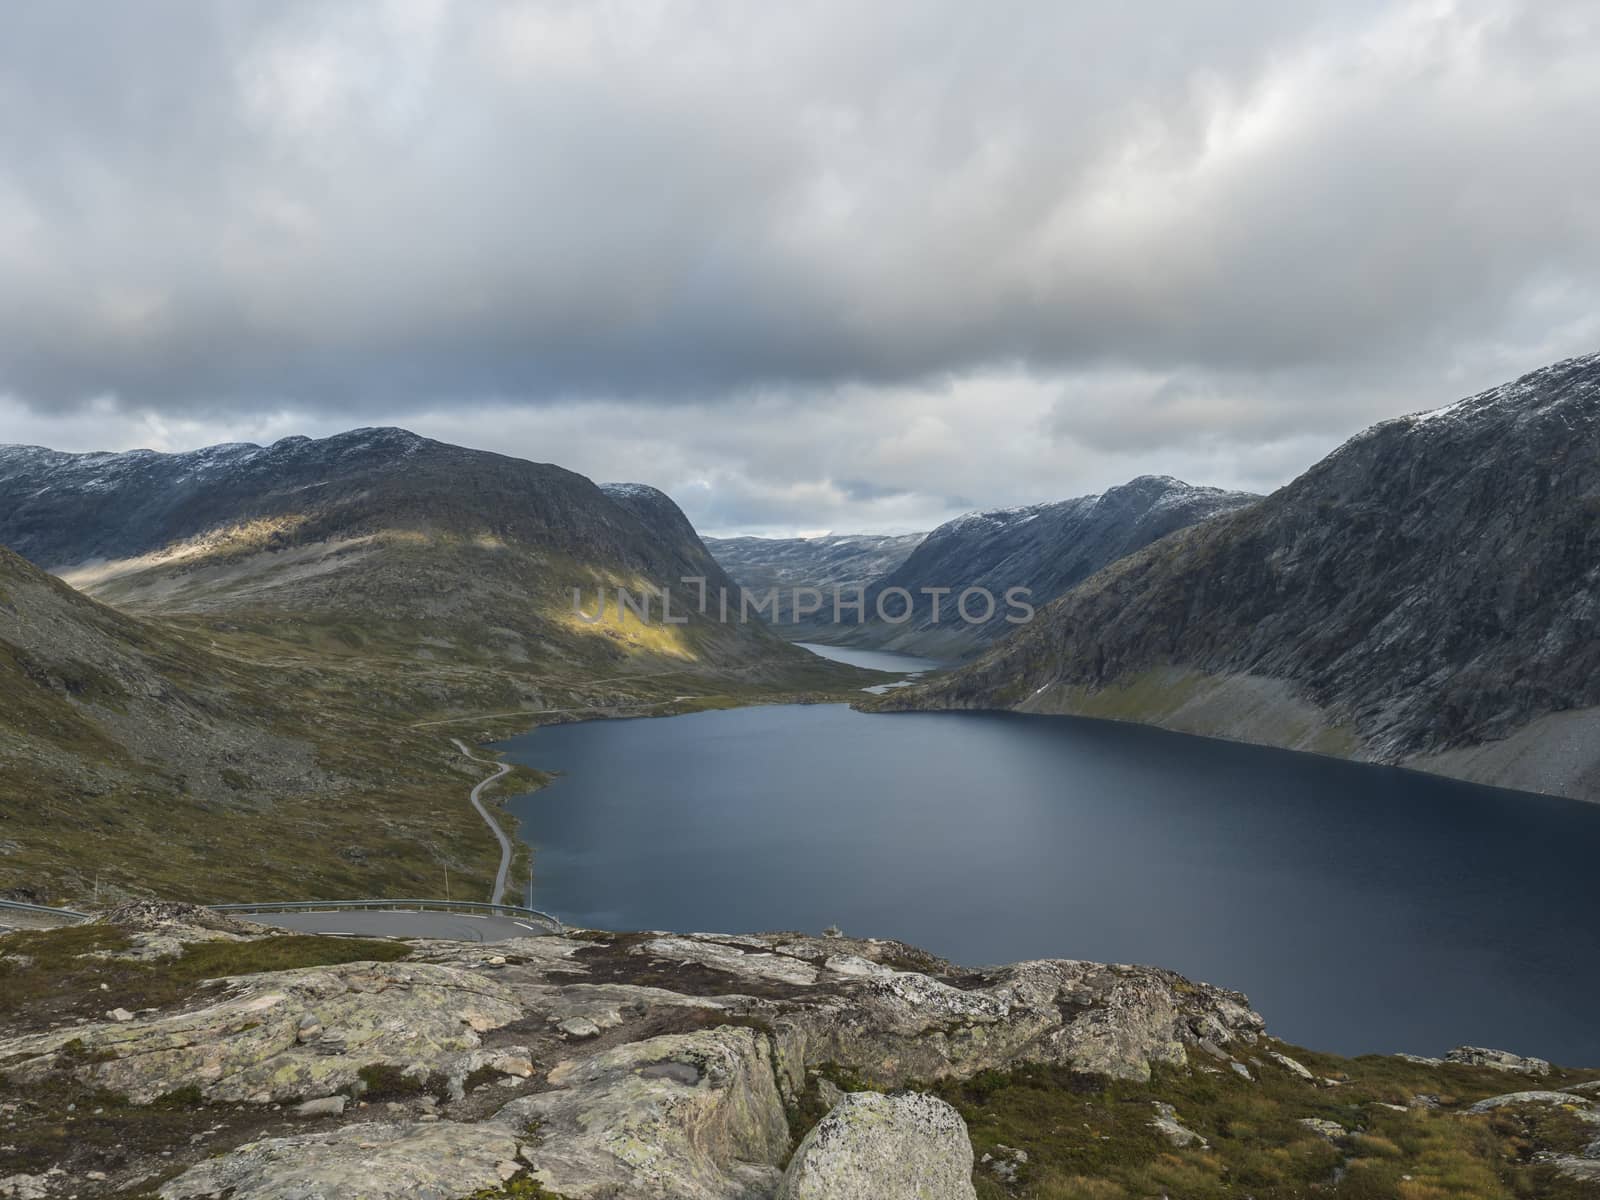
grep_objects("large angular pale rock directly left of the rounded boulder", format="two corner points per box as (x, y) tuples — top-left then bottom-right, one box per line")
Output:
(496, 1026), (789, 1200)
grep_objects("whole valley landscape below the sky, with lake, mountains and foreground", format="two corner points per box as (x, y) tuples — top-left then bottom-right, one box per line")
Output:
(0, 357), (1600, 1200)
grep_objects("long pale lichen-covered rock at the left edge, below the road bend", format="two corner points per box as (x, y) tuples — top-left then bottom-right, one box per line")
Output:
(0, 962), (523, 1104)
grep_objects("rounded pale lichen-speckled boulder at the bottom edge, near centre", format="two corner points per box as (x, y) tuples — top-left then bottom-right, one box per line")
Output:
(778, 1091), (978, 1200)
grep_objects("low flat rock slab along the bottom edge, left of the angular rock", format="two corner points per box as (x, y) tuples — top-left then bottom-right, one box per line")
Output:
(158, 1122), (520, 1200)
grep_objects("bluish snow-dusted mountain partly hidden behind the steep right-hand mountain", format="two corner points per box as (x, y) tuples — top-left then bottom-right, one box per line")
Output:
(798, 475), (1259, 659)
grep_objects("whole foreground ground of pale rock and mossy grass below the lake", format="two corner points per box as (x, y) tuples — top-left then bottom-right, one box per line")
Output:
(0, 904), (1600, 1200)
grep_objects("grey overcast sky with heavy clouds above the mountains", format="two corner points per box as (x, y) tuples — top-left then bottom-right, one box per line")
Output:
(0, 0), (1600, 533)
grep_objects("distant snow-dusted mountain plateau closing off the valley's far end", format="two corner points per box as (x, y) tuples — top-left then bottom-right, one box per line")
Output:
(702, 533), (928, 632)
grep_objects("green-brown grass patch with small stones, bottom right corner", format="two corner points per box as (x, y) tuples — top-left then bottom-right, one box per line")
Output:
(930, 1043), (1595, 1200)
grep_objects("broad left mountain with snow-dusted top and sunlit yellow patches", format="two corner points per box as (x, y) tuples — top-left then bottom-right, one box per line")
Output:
(0, 429), (851, 694)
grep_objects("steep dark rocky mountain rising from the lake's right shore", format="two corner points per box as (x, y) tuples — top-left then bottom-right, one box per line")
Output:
(875, 355), (1600, 798)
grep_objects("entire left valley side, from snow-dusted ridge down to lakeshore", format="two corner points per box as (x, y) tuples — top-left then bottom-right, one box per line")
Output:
(0, 430), (872, 902)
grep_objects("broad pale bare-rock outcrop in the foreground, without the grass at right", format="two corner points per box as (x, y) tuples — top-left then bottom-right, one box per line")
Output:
(0, 925), (1262, 1200)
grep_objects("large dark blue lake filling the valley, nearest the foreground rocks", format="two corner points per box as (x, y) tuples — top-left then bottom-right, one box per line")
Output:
(501, 704), (1600, 1066)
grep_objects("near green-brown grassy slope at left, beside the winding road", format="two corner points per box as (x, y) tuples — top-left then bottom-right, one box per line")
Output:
(0, 549), (582, 902)
